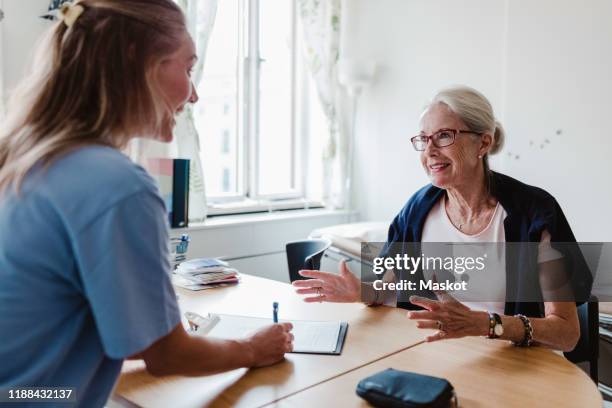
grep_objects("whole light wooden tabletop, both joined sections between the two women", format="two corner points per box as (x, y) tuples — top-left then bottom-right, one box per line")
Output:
(114, 275), (601, 407)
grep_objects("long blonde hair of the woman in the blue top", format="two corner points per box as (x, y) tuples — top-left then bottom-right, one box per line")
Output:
(0, 0), (186, 192)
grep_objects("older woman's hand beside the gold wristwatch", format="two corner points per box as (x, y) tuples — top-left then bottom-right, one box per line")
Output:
(407, 292), (489, 342)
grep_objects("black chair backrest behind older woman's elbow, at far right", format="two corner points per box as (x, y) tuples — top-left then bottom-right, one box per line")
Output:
(563, 296), (599, 384)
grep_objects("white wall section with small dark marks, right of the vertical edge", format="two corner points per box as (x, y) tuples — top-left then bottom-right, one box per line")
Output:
(503, 0), (612, 241)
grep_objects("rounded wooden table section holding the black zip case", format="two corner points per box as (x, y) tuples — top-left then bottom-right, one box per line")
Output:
(270, 337), (602, 408)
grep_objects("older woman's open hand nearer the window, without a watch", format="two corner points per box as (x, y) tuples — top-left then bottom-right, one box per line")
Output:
(293, 260), (361, 303)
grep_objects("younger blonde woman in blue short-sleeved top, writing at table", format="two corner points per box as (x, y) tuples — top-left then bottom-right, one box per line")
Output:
(0, 0), (293, 407)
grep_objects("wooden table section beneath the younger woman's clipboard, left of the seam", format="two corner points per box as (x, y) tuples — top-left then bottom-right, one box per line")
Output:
(115, 275), (426, 408)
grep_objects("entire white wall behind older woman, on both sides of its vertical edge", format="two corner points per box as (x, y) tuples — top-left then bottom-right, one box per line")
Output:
(346, 0), (612, 241)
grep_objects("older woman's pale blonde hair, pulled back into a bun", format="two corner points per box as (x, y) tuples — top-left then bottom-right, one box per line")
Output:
(429, 86), (506, 176)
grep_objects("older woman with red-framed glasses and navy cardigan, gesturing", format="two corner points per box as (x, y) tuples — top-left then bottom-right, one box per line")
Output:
(293, 87), (592, 351)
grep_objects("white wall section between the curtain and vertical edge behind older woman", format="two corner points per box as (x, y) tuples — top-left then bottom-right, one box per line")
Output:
(345, 0), (504, 225)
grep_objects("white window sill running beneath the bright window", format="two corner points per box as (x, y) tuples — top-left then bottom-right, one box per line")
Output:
(171, 208), (357, 231)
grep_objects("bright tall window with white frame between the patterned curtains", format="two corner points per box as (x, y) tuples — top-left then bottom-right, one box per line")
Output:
(195, 0), (318, 214)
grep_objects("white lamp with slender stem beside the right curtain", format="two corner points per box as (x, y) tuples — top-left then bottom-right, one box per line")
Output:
(338, 58), (377, 222)
